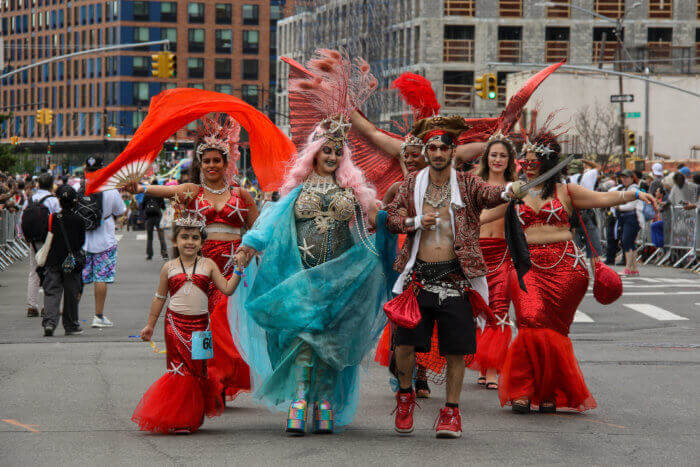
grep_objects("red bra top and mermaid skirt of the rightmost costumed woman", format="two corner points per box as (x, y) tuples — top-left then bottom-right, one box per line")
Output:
(498, 194), (596, 411)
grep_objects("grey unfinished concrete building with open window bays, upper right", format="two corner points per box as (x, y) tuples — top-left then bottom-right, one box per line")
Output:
(277, 0), (700, 134)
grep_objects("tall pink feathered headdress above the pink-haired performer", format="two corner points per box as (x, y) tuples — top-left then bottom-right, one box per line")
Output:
(289, 49), (377, 142)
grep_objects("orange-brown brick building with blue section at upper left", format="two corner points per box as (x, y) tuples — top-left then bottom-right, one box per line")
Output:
(0, 0), (284, 167)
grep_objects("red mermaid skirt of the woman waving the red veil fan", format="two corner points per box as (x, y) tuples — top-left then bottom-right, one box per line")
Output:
(202, 240), (251, 401)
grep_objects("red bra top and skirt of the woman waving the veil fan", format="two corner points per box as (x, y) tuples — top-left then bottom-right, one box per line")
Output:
(190, 187), (251, 401)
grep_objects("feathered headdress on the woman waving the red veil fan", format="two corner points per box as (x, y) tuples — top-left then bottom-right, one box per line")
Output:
(192, 115), (241, 184)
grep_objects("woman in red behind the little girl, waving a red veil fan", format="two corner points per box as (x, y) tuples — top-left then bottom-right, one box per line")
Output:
(127, 117), (258, 401)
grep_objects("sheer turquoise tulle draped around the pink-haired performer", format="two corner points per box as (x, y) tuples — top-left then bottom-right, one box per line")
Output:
(229, 188), (396, 426)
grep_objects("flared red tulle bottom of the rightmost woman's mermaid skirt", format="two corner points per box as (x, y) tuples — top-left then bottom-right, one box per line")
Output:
(498, 328), (596, 412)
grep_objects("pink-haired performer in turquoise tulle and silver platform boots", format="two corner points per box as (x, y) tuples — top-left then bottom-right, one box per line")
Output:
(229, 50), (395, 435)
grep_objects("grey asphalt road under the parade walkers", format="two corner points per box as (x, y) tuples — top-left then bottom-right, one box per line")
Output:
(0, 232), (700, 466)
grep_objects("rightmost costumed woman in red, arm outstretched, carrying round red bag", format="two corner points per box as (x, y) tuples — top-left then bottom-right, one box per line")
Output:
(499, 123), (656, 413)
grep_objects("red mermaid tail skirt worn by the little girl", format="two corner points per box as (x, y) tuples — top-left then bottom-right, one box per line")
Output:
(131, 310), (223, 433)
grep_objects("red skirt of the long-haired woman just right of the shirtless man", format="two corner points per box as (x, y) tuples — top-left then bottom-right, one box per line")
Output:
(469, 238), (511, 374)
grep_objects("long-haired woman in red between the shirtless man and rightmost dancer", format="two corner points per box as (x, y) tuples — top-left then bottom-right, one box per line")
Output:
(469, 131), (517, 389)
